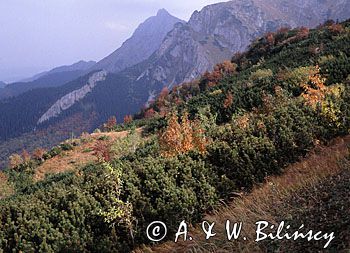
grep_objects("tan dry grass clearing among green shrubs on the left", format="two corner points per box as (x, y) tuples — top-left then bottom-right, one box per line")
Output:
(34, 129), (136, 180)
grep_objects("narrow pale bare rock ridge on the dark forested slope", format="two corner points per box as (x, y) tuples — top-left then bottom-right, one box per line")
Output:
(37, 71), (107, 124)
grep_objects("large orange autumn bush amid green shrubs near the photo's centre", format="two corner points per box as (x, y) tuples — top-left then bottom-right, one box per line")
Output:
(159, 112), (207, 157)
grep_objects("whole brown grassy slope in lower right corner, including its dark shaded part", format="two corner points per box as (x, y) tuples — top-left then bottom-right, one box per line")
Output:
(144, 136), (350, 253)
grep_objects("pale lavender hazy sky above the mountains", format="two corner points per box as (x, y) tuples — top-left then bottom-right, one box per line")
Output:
(0, 0), (221, 82)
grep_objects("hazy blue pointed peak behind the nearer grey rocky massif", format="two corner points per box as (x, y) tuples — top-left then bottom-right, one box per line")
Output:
(92, 9), (184, 73)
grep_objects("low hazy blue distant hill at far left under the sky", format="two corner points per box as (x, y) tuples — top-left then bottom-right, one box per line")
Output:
(0, 61), (96, 100)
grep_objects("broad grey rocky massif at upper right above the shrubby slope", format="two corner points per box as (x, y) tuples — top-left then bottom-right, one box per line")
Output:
(137, 0), (350, 93)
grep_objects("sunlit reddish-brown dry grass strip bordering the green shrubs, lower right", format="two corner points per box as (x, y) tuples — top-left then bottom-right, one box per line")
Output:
(135, 136), (350, 253)
